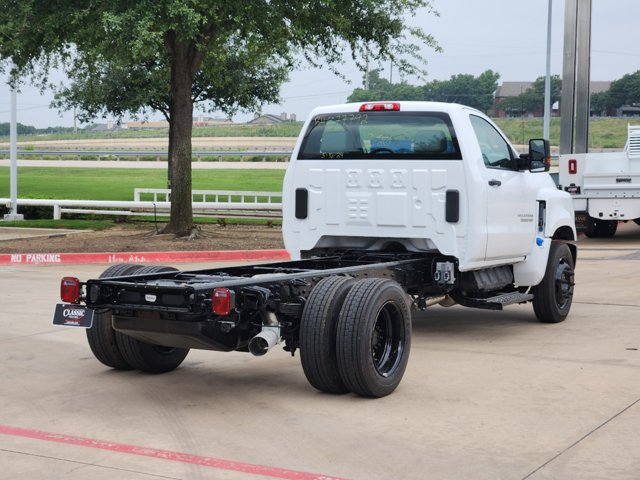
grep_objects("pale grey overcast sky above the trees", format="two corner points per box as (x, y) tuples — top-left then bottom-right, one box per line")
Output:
(0, 0), (640, 128)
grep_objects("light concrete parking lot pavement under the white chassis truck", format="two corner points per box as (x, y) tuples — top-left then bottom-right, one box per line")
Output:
(0, 224), (640, 480)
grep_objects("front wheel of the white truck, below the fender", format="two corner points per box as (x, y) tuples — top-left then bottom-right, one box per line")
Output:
(533, 241), (575, 323)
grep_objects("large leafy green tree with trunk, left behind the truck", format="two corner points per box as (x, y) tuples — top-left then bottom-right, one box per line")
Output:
(0, 0), (436, 234)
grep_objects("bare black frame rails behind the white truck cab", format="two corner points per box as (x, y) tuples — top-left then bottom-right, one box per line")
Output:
(85, 251), (444, 317)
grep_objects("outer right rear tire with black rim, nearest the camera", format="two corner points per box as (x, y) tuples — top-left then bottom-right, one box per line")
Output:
(336, 278), (411, 397)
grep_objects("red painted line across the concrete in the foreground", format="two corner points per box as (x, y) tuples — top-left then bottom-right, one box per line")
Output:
(0, 425), (344, 480)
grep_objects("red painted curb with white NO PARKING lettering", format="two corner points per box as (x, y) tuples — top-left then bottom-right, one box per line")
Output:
(0, 250), (291, 265)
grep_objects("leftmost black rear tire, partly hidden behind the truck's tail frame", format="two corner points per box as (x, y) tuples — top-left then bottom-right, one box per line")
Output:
(87, 263), (143, 370)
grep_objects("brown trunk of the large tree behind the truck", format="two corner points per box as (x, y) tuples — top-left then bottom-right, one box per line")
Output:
(163, 42), (193, 236)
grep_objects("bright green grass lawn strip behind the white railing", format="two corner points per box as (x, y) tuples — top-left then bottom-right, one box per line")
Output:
(0, 167), (284, 200)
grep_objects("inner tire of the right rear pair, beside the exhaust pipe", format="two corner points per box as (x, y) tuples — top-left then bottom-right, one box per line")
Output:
(300, 276), (355, 393)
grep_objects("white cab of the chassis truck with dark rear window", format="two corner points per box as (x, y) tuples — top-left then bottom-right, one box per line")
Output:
(283, 102), (575, 285)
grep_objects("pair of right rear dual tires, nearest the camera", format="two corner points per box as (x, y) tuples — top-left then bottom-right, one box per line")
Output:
(300, 277), (411, 397)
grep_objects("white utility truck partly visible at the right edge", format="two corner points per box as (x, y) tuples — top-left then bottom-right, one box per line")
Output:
(558, 125), (640, 237)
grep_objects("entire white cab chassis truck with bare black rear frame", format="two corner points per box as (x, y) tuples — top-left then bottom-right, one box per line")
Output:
(54, 102), (577, 397)
